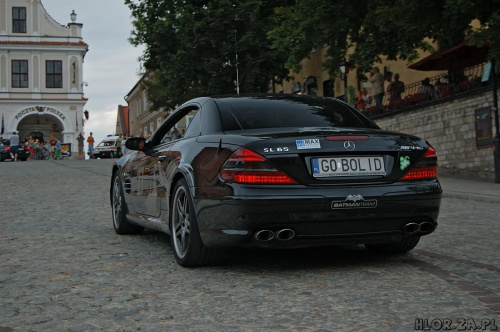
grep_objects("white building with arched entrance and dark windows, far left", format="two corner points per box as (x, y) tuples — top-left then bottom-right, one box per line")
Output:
(0, 0), (88, 156)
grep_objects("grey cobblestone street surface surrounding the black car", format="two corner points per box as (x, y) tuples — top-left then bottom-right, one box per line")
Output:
(0, 160), (500, 332)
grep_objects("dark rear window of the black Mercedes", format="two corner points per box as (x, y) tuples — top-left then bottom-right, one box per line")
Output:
(216, 97), (370, 131)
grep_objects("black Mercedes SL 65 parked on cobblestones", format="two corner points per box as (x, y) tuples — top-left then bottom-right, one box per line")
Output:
(110, 95), (442, 266)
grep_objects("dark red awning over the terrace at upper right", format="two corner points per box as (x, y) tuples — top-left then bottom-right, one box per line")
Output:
(408, 41), (489, 71)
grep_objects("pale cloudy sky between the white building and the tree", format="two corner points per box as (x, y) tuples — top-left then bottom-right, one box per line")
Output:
(42, 0), (144, 145)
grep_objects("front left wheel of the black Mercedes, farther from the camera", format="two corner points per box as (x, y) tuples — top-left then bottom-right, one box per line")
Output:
(111, 172), (144, 235)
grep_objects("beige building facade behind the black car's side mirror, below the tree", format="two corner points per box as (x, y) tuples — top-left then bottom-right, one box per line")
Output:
(124, 73), (167, 137)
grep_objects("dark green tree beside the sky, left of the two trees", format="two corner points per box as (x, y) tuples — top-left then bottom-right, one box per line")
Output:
(125, 0), (288, 110)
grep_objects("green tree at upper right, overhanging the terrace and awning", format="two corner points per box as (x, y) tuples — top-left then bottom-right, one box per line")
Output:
(269, 0), (500, 76)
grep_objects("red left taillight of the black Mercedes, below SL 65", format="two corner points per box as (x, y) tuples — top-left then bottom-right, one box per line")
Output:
(220, 148), (298, 184)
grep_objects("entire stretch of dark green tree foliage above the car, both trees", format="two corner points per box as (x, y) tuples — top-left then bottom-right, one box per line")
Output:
(128, 0), (500, 110)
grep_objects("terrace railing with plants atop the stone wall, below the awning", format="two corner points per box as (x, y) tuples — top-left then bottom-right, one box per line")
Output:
(365, 63), (490, 117)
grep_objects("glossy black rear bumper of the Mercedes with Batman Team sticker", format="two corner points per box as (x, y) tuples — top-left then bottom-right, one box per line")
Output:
(195, 181), (442, 248)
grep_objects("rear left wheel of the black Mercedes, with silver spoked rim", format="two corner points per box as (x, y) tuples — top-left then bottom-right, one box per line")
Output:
(170, 179), (220, 267)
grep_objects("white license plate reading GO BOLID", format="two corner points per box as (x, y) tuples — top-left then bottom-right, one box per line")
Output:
(312, 156), (385, 178)
